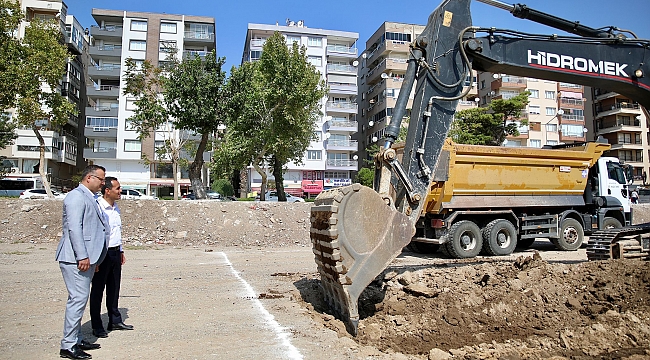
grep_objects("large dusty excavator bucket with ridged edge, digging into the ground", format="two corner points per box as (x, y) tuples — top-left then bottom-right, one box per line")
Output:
(310, 184), (415, 335)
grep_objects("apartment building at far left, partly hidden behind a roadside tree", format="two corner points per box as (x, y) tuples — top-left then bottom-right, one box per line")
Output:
(0, 0), (87, 189)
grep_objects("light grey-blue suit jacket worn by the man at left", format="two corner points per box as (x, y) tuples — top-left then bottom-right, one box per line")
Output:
(56, 185), (110, 265)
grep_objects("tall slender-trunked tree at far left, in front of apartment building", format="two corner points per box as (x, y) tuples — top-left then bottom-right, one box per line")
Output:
(0, 0), (75, 198)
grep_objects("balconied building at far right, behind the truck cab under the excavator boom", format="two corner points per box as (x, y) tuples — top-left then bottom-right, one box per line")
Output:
(588, 88), (650, 185)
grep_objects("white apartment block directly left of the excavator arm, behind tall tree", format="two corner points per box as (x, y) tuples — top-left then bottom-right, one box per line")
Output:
(242, 20), (359, 197)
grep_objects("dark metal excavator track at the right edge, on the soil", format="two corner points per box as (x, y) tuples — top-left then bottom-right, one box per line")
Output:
(587, 223), (650, 261)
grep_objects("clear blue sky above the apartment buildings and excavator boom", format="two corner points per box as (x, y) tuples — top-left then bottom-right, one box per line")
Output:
(63, 0), (650, 70)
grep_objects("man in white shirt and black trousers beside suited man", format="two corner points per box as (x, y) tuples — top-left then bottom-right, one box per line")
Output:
(90, 176), (133, 337)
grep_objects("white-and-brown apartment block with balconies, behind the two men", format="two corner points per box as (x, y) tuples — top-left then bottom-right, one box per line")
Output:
(83, 9), (216, 196)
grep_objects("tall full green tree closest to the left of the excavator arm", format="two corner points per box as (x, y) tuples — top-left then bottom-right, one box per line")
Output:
(219, 32), (327, 201)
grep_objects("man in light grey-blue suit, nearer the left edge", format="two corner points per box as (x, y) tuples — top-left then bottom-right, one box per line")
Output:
(56, 165), (110, 359)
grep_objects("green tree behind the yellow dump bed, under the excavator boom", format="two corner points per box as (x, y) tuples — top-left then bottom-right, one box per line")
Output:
(449, 91), (530, 146)
